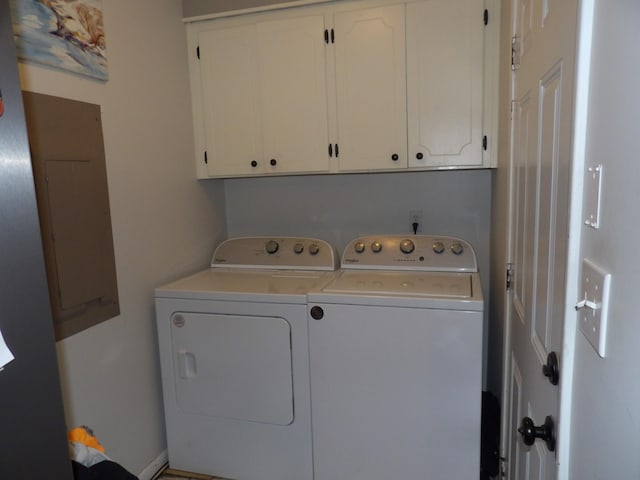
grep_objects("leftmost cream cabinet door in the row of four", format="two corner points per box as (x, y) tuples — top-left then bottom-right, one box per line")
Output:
(196, 25), (264, 176)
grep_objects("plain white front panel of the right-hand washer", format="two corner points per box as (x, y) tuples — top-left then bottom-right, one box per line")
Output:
(309, 304), (482, 480)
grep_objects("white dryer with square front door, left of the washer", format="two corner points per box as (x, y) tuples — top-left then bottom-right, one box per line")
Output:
(155, 237), (337, 480)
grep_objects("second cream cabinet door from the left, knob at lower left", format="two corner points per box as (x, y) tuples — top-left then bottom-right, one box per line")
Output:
(258, 15), (329, 173)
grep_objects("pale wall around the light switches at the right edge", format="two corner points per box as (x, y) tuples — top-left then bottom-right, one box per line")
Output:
(569, 0), (640, 479)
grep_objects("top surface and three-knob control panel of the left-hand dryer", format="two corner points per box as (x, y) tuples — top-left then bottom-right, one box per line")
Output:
(155, 237), (338, 303)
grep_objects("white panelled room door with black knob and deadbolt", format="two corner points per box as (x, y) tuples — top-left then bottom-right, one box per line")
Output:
(503, 0), (578, 480)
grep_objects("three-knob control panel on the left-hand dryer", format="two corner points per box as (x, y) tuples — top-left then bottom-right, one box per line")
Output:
(211, 237), (338, 270)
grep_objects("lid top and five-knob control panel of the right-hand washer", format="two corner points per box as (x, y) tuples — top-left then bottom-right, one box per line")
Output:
(309, 235), (484, 311)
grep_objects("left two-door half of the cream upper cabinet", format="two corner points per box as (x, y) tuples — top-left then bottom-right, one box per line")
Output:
(192, 15), (329, 178)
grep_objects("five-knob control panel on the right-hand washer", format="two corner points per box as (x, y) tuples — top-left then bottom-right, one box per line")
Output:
(341, 235), (478, 272)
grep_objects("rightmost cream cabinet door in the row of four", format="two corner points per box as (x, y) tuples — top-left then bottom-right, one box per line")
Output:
(407, 0), (484, 168)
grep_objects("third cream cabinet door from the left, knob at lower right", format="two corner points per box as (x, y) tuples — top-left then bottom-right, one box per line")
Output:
(335, 5), (407, 171)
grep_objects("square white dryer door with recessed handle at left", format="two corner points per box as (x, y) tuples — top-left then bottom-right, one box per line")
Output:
(171, 312), (293, 425)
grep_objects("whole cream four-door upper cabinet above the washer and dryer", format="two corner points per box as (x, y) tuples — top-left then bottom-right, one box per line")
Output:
(187, 0), (499, 178)
